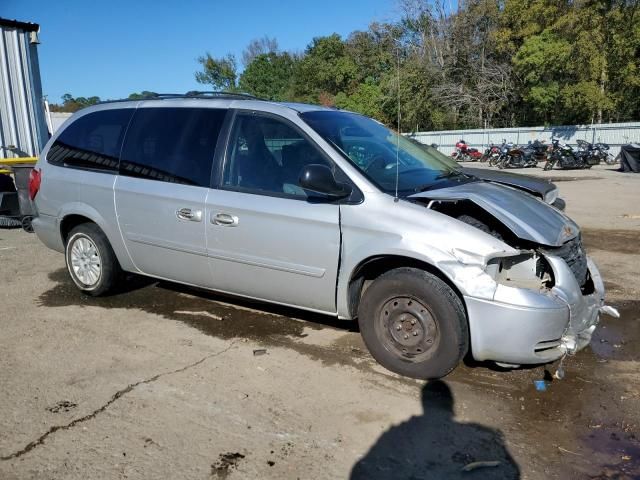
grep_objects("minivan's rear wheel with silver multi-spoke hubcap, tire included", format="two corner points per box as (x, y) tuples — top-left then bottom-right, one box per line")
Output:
(65, 223), (122, 297)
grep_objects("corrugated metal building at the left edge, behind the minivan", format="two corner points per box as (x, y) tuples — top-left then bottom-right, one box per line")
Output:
(0, 18), (49, 158)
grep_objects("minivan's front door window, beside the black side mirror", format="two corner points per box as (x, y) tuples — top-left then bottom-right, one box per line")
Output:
(223, 113), (331, 198)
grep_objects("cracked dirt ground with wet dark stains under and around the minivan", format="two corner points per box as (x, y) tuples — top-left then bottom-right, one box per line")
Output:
(0, 166), (640, 480)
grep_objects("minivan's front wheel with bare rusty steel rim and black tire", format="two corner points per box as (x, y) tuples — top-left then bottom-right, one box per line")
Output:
(358, 267), (469, 379)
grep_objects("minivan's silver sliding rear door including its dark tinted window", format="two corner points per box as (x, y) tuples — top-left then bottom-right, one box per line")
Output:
(115, 106), (227, 286)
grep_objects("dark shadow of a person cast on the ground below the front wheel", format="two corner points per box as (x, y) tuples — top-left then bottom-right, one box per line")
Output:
(350, 380), (520, 480)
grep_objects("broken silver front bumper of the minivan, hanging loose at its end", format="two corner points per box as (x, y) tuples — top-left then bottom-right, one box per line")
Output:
(465, 255), (604, 364)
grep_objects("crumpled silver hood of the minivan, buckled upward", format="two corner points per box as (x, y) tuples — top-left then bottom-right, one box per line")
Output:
(410, 182), (580, 247)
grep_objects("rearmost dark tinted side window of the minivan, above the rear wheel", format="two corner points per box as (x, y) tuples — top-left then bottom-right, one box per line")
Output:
(47, 108), (134, 172)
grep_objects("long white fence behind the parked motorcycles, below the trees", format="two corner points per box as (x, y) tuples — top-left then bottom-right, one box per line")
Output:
(409, 122), (640, 155)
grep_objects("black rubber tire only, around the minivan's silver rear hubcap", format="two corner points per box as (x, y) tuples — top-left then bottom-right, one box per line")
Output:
(65, 223), (123, 297)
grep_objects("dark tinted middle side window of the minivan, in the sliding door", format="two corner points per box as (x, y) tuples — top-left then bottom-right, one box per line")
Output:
(120, 107), (227, 187)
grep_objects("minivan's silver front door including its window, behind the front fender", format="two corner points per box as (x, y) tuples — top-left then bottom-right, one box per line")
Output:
(206, 112), (340, 313)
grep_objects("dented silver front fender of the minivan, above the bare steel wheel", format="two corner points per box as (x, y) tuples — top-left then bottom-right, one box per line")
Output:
(336, 194), (520, 319)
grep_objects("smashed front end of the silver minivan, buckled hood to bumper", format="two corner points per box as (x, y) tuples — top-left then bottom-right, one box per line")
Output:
(412, 182), (617, 366)
